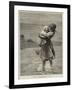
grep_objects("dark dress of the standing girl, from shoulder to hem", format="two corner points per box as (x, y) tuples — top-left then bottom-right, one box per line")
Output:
(40, 33), (55, 61)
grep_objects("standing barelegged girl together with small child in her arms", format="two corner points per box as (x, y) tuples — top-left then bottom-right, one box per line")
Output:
(39, 24), (56, 71)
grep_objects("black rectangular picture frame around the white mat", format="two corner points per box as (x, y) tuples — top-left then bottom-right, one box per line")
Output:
(9, 1), (70, 89)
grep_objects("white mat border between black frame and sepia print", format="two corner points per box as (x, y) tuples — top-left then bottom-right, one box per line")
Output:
(14, 5), (67, 85)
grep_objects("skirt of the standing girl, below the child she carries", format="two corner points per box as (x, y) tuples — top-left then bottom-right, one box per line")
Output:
(40, 41), (53, 61)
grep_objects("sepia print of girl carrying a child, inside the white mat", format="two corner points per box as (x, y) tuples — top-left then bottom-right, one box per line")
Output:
(18, 10), (63, 76)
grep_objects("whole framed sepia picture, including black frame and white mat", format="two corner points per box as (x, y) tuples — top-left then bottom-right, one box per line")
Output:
(9, 1), (70, 89)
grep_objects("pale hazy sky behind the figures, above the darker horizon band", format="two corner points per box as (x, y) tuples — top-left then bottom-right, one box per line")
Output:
(19, 10), (63, 42)
